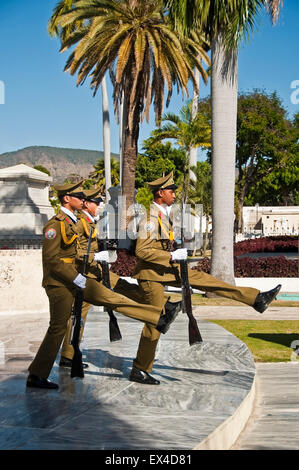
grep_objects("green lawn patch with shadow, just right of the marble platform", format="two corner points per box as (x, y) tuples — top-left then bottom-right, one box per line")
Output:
(211, 320), (299, 362)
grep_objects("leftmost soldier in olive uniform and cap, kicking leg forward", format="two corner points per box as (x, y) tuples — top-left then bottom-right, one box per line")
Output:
(27, 183), (178, 389)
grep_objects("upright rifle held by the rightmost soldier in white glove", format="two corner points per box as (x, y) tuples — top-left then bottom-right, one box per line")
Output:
(180, 172), (202, 346)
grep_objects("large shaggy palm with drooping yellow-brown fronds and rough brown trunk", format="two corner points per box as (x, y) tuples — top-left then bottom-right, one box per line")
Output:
(50, 0), (209, 227)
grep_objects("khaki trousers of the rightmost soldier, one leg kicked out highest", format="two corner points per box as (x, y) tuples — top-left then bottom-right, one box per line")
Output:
(133, 267), (259, 372)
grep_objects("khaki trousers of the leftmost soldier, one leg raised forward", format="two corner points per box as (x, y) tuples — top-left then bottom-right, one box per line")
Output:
(29, 278), (163, 378)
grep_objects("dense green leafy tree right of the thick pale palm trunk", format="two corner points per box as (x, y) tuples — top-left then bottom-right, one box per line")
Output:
(236, 90), (299, 230)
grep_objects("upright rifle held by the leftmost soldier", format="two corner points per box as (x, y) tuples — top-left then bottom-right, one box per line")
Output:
(71, 228), (92, 379)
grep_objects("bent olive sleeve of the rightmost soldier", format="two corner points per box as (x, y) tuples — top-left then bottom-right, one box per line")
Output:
(136, 215), (171, 266)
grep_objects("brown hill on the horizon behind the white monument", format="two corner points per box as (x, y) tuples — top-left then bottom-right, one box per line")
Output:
(0, 146), (119, 182)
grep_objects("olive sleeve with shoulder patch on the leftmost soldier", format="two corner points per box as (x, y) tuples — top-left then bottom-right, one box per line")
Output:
(42, 220), (78, 283)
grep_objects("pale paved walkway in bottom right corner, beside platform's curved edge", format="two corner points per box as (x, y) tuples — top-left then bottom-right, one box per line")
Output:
(232, 362), (299, 450)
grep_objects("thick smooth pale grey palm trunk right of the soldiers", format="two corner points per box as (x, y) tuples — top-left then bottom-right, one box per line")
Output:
(211, 36), (238, 284)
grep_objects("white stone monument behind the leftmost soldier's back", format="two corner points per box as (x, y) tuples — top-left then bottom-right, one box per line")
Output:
(0, 164), (54, 249)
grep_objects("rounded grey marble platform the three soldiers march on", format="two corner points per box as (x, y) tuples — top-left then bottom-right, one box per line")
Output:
(0, 308), (255, 450)
